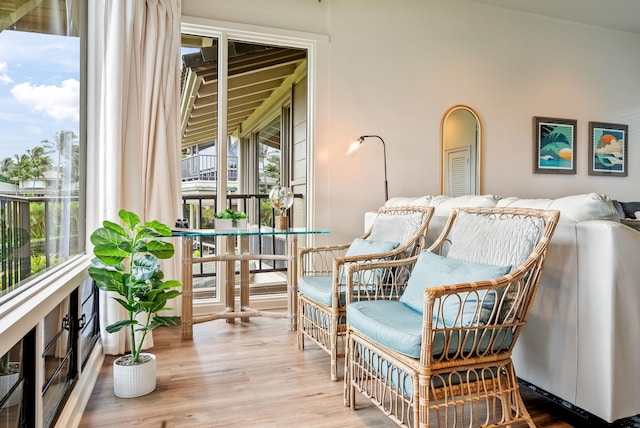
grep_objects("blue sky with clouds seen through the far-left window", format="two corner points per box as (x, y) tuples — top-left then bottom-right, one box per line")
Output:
(0, 30), (80, 160)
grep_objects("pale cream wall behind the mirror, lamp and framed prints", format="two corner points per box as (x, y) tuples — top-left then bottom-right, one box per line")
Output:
(183, 0), (640, 240)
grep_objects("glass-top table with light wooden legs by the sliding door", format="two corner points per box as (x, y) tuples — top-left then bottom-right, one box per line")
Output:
(172, 226), (331, 340)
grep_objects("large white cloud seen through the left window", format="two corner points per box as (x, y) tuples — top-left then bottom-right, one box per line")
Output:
(11, 79), (80, 122)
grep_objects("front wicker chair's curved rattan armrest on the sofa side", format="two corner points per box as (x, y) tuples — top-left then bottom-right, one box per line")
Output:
(420, 260), (540, 366)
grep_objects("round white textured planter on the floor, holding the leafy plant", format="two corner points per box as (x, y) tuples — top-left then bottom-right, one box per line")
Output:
(113, 352), (156, 398)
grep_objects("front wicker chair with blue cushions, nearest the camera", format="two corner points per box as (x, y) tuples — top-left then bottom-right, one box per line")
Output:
(344, 208), (560, 428)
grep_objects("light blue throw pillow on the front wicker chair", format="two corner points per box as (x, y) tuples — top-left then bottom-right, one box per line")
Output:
(400, 251), (511, 327)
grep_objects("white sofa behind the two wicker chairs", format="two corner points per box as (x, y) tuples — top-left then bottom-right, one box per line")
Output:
(365, 193), (640, 422)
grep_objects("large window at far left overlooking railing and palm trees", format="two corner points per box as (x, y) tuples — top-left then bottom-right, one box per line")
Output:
(0, 0), (83, 301)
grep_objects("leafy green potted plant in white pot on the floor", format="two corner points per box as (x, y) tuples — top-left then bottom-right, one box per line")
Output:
(89, 210), (182, 398)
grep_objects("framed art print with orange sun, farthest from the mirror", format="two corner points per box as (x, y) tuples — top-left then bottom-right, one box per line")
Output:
(589, 122), (629, 177)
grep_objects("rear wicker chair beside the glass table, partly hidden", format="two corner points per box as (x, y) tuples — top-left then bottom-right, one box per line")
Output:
(298, 206), (433, 381)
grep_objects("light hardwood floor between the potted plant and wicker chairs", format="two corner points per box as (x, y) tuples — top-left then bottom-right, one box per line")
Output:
(80, 318), (574, 428)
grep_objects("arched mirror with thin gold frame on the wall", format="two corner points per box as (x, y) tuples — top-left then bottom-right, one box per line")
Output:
(440, 105), (482, 196)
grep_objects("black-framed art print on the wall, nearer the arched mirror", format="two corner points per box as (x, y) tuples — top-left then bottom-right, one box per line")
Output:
(533, 116), (577, 174)
